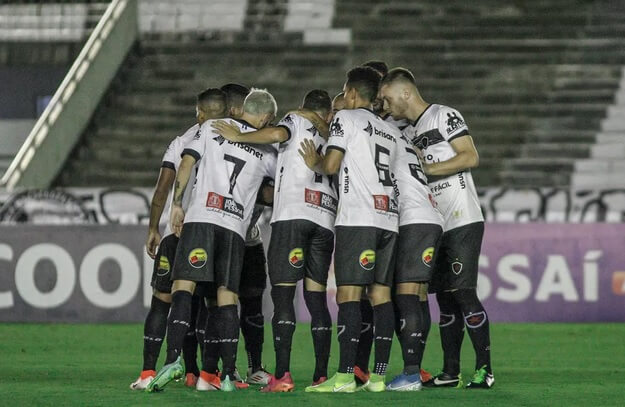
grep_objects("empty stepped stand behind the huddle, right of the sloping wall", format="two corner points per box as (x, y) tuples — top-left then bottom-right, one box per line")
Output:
(1, 0), (625, 189)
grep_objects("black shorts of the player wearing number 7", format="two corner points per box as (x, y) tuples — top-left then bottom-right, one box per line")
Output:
(172, 222), (245, 293)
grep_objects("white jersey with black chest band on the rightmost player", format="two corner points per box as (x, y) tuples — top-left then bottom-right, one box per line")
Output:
(403, 104), (484, 231)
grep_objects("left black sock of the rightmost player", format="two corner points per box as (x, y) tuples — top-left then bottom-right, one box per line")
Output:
(436, 292), (464, 376)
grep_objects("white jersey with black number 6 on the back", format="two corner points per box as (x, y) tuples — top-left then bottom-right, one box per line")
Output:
(327, 108), (401, 232)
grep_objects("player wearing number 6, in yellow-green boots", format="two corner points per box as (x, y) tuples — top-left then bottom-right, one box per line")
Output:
(301, 67), (401, 392)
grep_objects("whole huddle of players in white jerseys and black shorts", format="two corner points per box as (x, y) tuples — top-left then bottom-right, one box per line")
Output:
(130, 61), (494, 393)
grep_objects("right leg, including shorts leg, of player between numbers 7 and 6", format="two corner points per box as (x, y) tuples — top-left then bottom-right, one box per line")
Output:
(304, 225), (334, 385)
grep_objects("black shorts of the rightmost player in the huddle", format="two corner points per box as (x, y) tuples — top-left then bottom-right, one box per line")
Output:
(430, 222), (484, 293)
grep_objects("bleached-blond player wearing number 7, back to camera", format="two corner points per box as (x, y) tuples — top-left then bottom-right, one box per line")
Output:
(146, 89), (277, 391)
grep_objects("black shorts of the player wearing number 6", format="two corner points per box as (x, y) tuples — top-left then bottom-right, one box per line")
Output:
(334, 226), (397, 286)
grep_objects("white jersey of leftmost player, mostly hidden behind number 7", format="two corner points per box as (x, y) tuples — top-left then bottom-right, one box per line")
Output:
(161, 124), (200, 239)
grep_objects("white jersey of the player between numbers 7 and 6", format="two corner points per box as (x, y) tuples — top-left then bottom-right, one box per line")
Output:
(271, 114), (338, 230)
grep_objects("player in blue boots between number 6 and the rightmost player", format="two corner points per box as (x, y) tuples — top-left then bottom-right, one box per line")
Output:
(386, 136), (443, 391)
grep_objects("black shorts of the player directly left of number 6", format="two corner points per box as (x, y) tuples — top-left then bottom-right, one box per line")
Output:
(267, 219), (334, 285)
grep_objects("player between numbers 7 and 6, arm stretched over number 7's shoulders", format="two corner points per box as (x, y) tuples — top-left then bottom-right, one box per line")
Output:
(212, 90), (338, 392)
